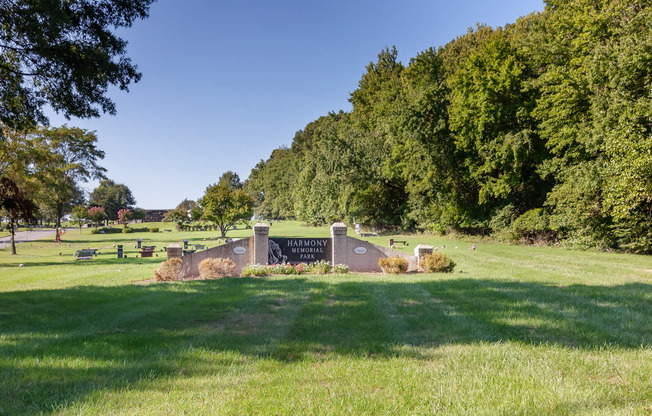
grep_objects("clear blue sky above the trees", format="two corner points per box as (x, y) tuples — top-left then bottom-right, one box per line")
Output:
(44, 0), (544, 209)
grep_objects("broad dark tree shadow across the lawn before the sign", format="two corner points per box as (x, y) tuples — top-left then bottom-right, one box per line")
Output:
(0, 277), (652, 414)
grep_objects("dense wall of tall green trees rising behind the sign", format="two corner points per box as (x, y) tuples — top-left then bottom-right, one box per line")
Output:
(247, 0), (652, 253)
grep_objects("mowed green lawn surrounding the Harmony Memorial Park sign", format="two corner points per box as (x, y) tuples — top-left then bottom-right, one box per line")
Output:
(0, 222), (652, 415)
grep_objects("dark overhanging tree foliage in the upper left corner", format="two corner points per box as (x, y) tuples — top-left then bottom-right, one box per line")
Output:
(0, 0), (154, 130)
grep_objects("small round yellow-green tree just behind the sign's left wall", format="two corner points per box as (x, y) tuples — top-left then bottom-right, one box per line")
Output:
(200, 184), (254, 237)
